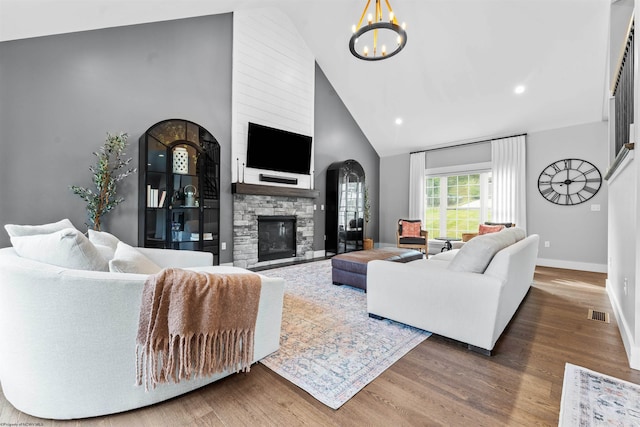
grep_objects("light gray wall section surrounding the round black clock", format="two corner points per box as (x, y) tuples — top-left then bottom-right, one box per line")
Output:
(527, 122), (609, 272)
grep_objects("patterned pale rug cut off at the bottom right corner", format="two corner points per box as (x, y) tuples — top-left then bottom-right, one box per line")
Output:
(558, 363), (640, 427)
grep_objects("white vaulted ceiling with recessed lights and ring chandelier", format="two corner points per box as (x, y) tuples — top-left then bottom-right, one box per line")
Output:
(0, 0), (611, 157)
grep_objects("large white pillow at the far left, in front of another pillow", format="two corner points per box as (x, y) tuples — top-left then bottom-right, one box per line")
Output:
(11, 228), (108, 271)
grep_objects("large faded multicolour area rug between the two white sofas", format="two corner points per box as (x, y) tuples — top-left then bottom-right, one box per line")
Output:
(260, 260), (431, 409)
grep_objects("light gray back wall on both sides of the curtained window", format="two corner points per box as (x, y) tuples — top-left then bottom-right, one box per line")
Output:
(380, 122), (608, 271)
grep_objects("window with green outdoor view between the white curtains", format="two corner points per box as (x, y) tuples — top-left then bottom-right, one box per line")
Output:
(424, 171), (491, 239)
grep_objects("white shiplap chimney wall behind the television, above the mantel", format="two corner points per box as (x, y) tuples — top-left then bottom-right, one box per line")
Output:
(231, 9), (315, 188)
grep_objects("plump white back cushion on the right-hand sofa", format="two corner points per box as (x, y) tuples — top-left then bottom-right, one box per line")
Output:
(448, 230), (516, 273)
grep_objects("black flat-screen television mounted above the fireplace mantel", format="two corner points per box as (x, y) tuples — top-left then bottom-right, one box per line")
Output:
(247, 122), (312, 175)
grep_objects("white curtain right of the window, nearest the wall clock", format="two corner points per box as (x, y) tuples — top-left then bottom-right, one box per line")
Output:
(491, 135), (527, 231)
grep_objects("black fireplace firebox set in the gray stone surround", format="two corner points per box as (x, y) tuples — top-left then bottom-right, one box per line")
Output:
(258, 215), (296, 262)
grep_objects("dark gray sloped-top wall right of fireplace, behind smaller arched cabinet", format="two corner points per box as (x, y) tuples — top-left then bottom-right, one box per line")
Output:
(314, 64), (381, 250)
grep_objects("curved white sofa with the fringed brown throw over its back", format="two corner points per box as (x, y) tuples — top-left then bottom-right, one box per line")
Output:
(0, 248), (284, 419)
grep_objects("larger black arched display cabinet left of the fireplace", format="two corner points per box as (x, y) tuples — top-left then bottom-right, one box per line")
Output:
(138, 120), (220, 264)
